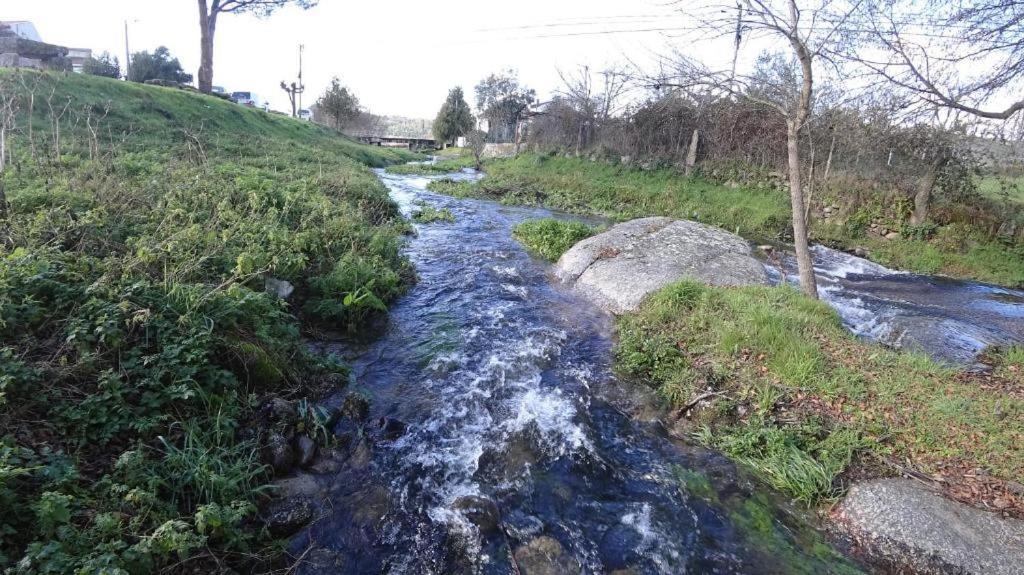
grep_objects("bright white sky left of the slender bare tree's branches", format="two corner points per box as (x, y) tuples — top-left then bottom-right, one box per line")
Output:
(0, 0), (720, 118)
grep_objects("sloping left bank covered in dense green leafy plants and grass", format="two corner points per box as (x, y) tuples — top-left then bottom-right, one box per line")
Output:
(0, 72), (412, 573)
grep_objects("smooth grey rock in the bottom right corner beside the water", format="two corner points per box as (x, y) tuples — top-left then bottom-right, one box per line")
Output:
(838, 479), (1024, 575)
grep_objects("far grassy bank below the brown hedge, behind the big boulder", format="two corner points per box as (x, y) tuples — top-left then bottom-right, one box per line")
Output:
(430, 154), (1024, 286)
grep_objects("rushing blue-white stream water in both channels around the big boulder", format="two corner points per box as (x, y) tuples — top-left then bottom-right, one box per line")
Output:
(292, 164), (1024, 574)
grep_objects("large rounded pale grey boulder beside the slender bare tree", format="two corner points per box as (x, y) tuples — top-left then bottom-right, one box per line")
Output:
(555, 217), (768, 313)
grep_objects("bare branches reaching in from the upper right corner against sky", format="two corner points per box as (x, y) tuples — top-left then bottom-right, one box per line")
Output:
(849, 0), (1024, 120)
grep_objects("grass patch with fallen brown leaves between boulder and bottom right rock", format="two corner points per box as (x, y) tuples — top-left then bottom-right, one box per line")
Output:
(615, 281), (1024, 504)
